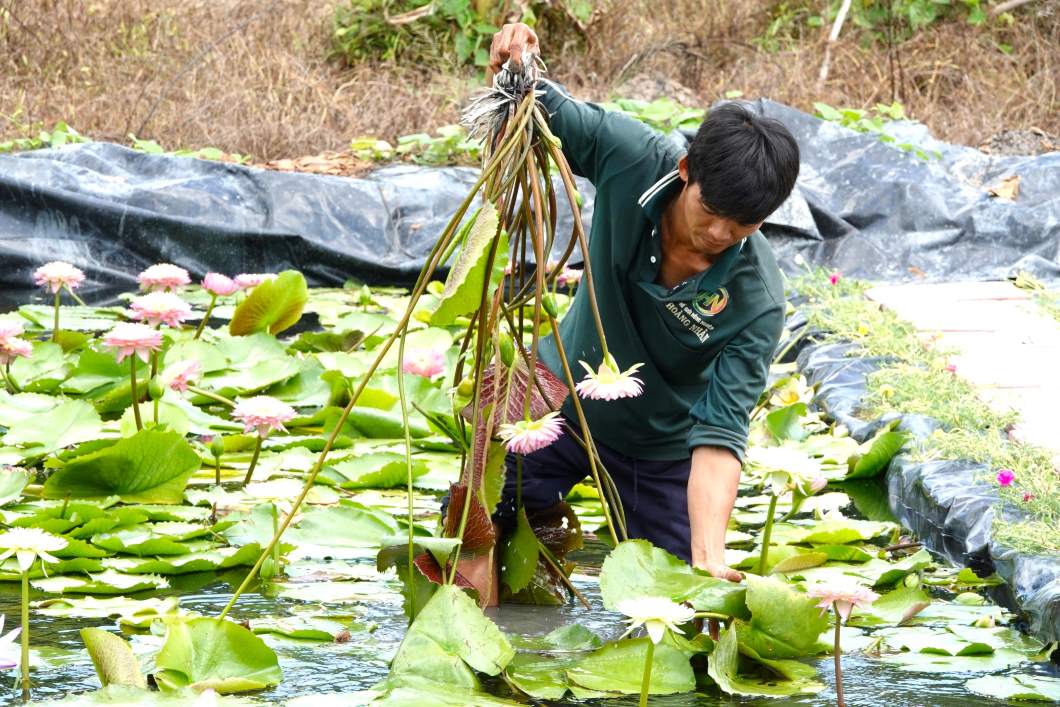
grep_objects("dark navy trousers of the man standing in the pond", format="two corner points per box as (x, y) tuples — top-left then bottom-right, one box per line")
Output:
(497, 421), (692, 562)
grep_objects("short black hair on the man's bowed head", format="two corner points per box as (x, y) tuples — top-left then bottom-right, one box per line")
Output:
(688, 103), (798, 226)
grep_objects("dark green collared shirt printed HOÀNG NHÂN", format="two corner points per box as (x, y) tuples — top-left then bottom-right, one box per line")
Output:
(540, 82), (784, 461)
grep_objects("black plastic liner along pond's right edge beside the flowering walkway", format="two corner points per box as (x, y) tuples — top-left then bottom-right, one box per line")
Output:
(797, 343), (1060, 642)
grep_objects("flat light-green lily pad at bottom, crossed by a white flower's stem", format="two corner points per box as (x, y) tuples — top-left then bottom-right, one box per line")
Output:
(566, 637), (695, 694)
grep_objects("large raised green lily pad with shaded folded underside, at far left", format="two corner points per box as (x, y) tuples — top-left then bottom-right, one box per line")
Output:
(43, 429), (200, 503)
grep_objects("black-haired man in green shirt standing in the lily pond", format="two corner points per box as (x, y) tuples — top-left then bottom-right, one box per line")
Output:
(490, 23), (799, 582)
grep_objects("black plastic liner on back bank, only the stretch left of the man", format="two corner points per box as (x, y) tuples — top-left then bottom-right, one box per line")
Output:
(0, 143), (595, 308)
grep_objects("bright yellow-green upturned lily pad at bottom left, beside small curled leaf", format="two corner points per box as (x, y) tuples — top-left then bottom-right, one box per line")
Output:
(155, 618), (282, 694)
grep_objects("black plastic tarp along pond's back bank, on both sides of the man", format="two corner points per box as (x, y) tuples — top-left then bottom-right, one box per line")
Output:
(0, 100), (1060, 304)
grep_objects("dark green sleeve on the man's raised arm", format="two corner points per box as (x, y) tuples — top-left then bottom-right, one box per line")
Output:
(537, 81), (667, 185)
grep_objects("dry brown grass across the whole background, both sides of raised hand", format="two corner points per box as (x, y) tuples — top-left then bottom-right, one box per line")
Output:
(0, 0), (1060, 160)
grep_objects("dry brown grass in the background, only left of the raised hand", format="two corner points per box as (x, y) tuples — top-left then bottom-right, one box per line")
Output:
(0, 0), (462, 159)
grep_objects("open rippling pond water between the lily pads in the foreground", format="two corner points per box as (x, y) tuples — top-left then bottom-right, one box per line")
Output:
(0, 536), (1058, 707)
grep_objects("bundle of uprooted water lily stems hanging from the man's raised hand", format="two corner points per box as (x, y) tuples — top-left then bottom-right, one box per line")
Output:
(222, 57), (625, 617)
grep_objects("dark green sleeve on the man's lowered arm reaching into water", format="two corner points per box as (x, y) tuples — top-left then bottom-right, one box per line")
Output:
(688, 307), (784, 463)
